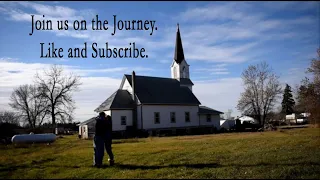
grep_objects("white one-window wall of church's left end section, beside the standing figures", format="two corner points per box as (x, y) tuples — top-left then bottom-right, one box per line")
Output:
(111, 110), (132, 131)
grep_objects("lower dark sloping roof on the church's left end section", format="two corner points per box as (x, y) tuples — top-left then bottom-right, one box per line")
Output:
(94, 89), (134, 112)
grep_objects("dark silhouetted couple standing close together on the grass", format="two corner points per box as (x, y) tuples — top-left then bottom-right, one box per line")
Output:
(93, 112), (114, 167)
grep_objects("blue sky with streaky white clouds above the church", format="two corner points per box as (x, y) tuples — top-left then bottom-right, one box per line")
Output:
(0, 2), (320, 121)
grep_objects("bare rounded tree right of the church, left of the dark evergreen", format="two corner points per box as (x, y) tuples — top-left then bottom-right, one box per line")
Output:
(237, 62), (282, 126)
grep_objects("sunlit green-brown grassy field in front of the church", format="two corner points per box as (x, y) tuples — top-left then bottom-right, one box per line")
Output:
(0, 128), (320, 179)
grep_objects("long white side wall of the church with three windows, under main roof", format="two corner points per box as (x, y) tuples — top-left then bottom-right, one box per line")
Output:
(138, 105), (199, 129)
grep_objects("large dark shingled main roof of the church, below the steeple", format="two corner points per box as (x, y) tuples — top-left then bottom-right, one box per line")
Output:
(125, 75), (201, 105)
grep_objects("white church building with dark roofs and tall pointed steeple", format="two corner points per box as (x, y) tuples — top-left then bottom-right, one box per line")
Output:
(79, 25), (222, 137)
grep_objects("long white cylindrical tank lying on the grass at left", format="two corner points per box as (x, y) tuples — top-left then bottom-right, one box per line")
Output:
(11, 133), (56, 144)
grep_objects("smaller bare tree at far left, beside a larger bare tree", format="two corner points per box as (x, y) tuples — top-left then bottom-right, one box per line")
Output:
(9, 84), (47, 128)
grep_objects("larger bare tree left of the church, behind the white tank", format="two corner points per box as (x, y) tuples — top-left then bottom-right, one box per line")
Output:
(35, 65), (81, 125)
